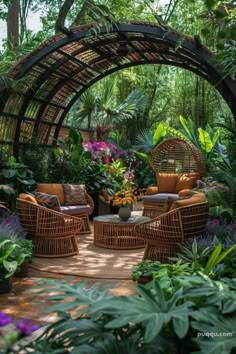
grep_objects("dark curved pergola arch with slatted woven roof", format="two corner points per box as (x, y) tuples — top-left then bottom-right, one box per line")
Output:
(0, 22), (236, 152)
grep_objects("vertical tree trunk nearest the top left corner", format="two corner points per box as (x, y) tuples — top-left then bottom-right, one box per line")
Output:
(7, 0), (20, 50)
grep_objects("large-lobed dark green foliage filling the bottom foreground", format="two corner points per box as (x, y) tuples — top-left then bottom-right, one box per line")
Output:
(3, 273), (236, 354)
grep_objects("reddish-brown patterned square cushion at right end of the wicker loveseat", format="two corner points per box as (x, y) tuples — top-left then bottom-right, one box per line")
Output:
(63, 184), (87, 205)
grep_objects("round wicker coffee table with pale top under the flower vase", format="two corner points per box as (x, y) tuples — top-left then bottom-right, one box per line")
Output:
(93, 213), (150, 250)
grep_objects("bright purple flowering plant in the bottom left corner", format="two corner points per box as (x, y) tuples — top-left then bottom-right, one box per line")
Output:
(0, 312), (40, 354)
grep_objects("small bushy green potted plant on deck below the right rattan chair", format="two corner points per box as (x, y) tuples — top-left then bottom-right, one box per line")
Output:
(131, 259), (161, 284)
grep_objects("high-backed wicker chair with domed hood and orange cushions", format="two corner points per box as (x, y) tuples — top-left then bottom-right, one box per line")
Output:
(143, 138), (205, 218)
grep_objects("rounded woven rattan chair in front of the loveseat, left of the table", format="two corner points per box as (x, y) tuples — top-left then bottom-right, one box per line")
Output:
(16, 199), (82, 257)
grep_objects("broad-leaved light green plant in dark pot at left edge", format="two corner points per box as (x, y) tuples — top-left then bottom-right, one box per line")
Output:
(0, 239), (25, 294)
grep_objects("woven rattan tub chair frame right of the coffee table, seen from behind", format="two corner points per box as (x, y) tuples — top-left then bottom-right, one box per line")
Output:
(135, 202), (208, 262)
